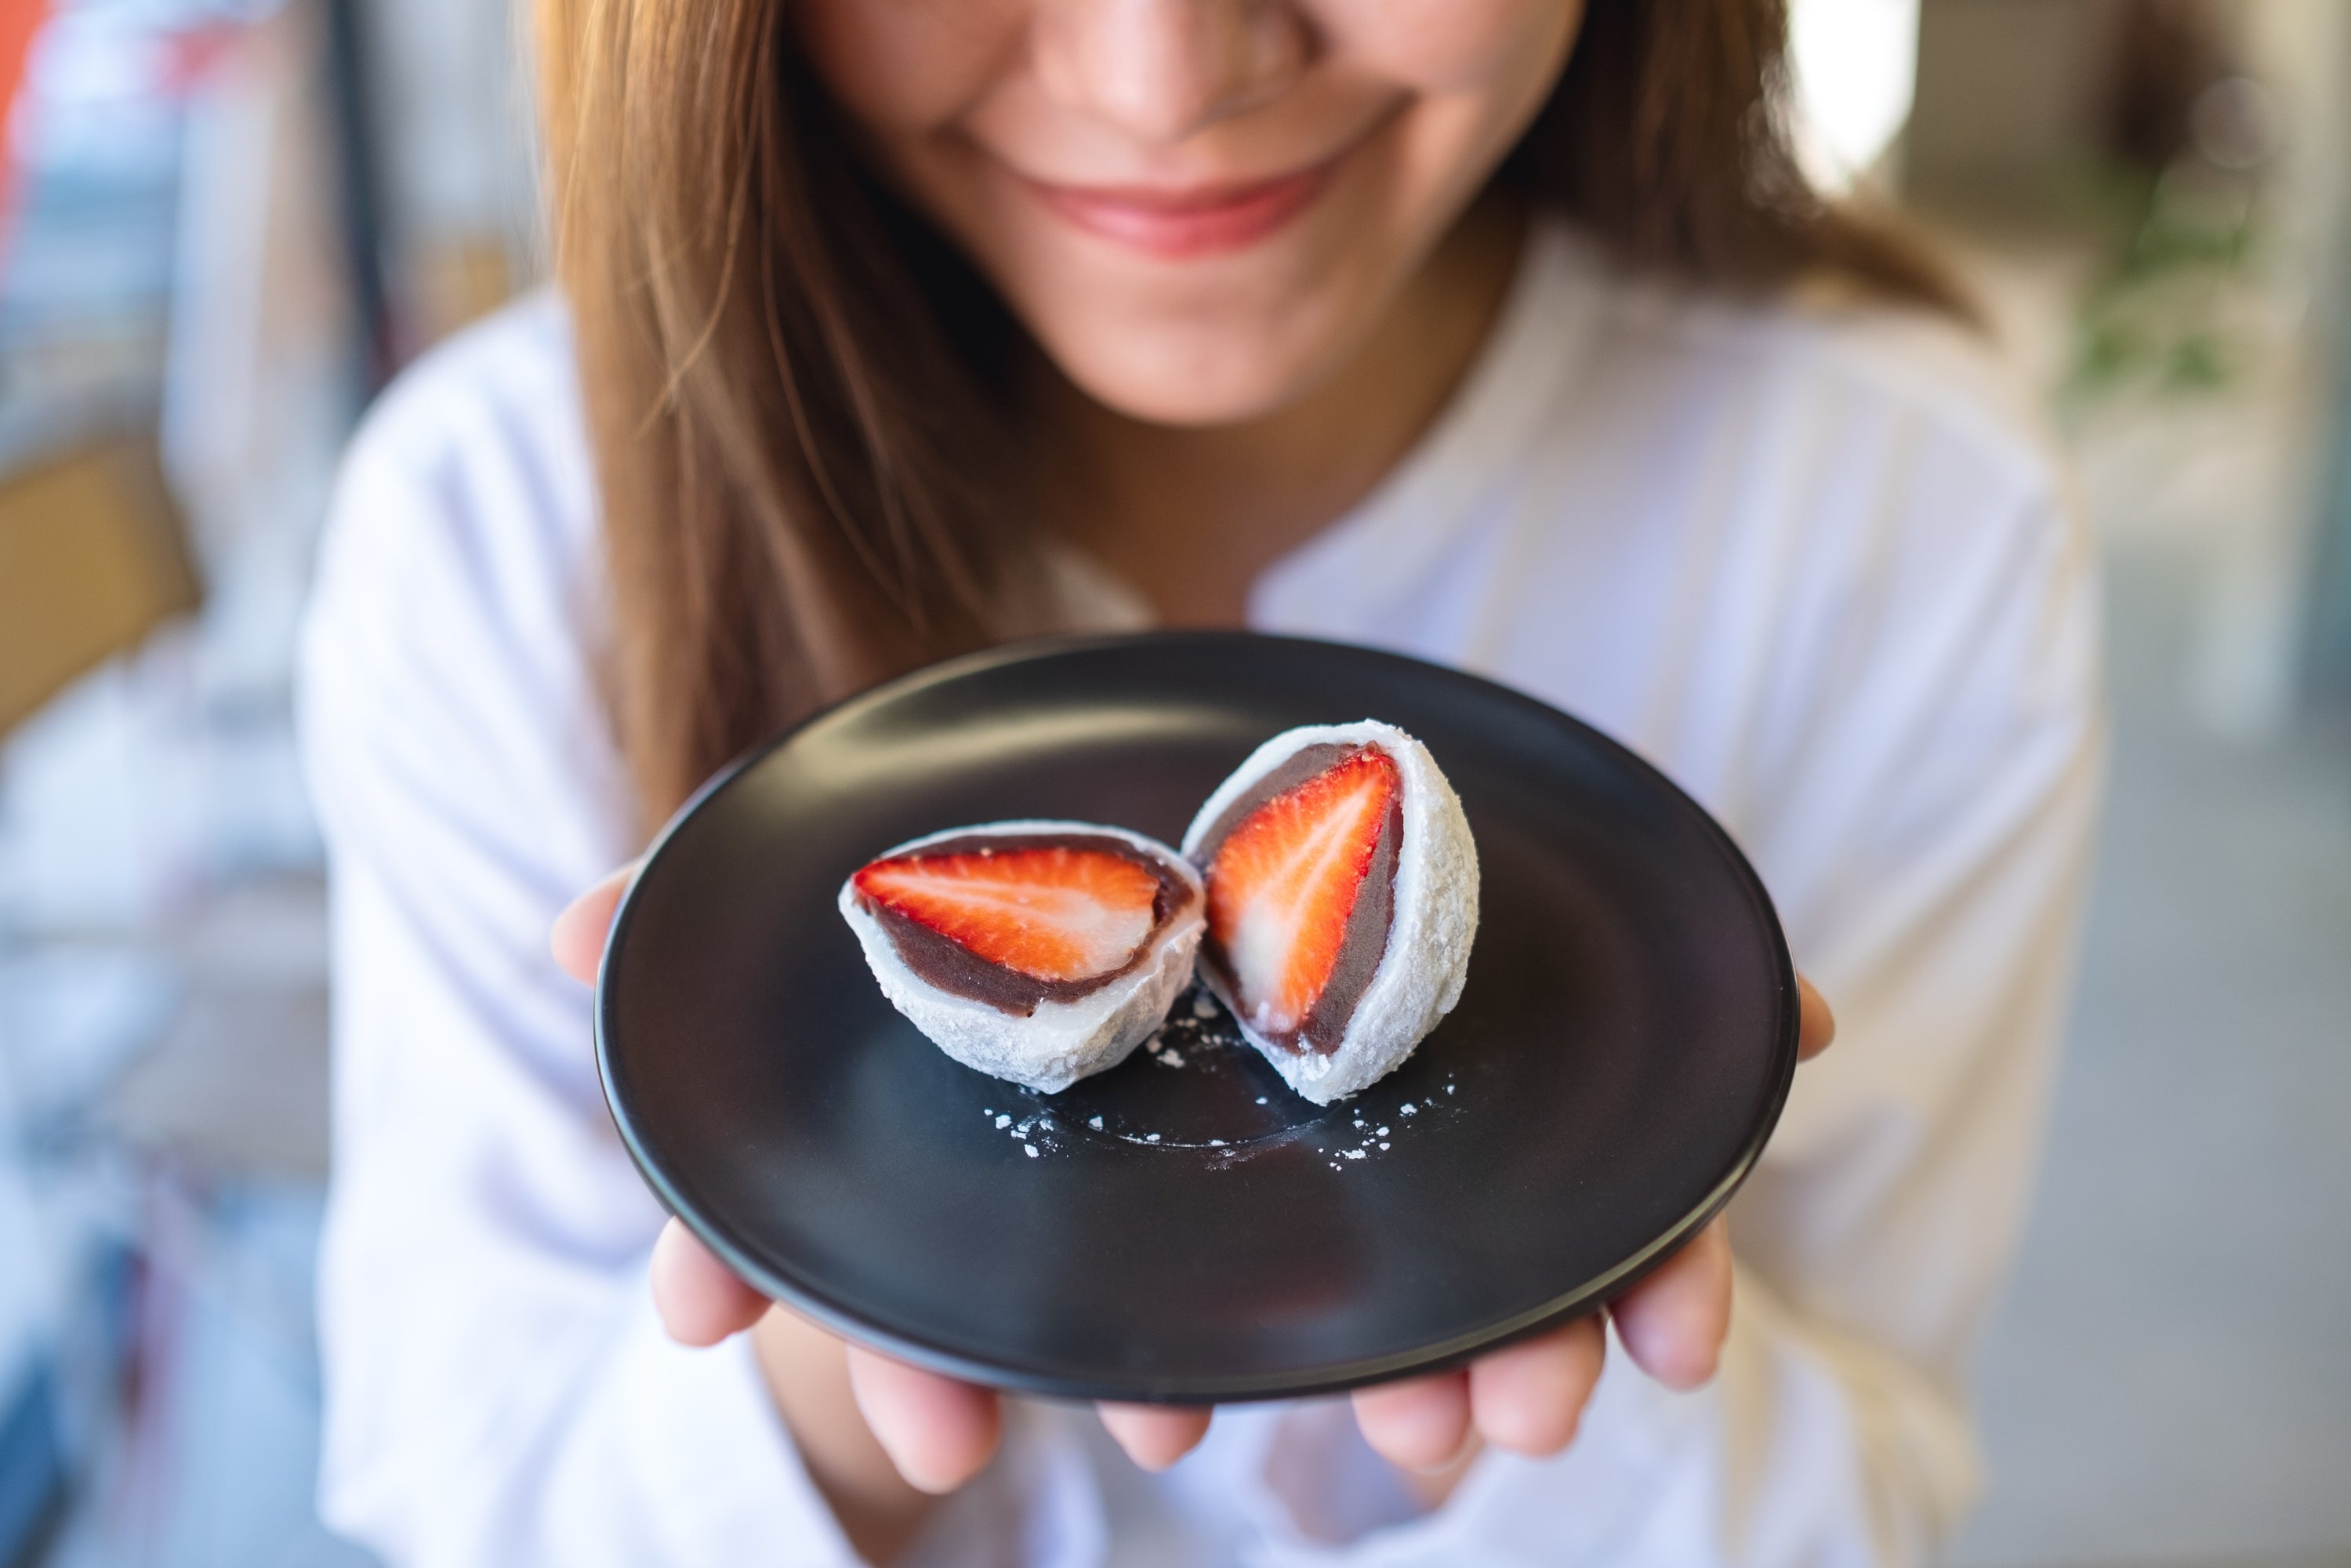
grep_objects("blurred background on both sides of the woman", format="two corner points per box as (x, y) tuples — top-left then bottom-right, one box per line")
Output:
(0, 0), (2351, 1568)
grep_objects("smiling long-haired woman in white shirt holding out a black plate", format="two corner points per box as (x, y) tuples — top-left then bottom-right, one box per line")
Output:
(303, 0), (2097, 1566)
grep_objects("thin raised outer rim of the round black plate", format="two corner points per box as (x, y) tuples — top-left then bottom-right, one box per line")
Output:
(590, 630), (1803, 1406)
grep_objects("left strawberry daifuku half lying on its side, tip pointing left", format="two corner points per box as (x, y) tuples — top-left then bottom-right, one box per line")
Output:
(840, 822), (1203, 1093)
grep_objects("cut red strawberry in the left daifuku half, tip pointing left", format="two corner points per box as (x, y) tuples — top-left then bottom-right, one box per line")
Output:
(854, 839), (1159, 985)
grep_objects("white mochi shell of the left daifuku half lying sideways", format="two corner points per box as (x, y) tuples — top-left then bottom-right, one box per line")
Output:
(840, 822), (1206, 1093)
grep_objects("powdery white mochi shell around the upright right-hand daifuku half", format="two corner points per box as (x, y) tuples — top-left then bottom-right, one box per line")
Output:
(1182, 720), (1476, 1105)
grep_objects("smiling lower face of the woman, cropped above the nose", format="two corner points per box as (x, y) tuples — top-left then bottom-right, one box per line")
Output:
(797, 0), (1582, 426)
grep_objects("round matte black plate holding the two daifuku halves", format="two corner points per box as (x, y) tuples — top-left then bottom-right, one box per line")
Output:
(597, 633), (1796, 1401)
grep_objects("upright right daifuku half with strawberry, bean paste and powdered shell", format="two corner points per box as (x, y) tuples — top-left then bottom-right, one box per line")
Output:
(1182, 720), (1476, 1105)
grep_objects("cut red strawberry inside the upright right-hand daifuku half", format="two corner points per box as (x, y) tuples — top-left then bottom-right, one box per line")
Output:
(1208, 746), (1401, 1036)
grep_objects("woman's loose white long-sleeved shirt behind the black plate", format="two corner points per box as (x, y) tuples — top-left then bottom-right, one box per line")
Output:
(303, 228), (2099, 1568)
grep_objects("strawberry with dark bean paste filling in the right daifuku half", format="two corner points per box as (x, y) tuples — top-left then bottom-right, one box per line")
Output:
(1206, 746), (1403, 1051)
